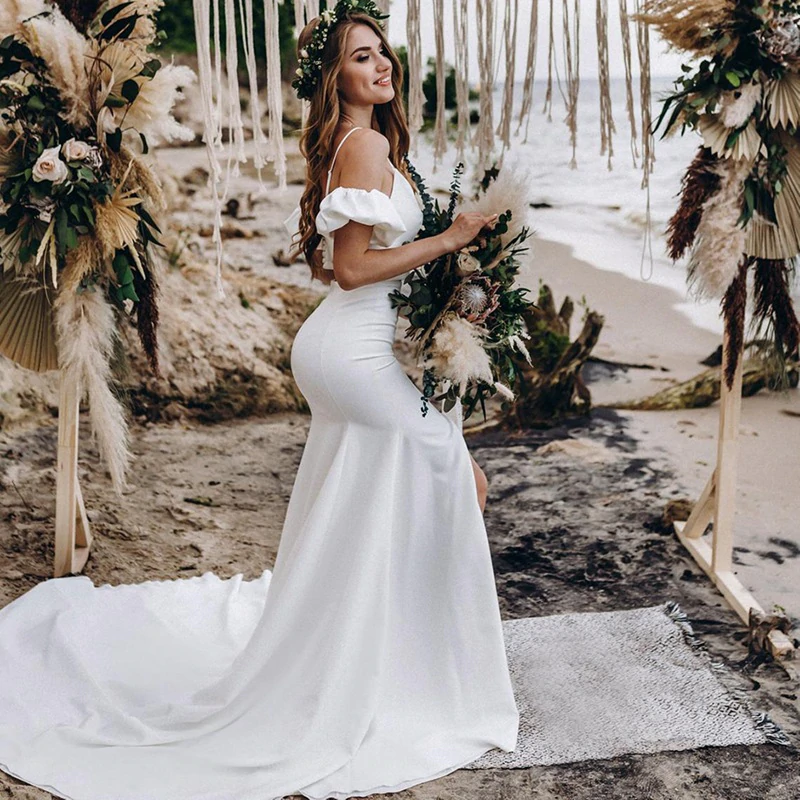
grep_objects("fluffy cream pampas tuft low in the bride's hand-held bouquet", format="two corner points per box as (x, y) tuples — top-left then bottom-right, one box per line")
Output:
(425, 314), (494, 397)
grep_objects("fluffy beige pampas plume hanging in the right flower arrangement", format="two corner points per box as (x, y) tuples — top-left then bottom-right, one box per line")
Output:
(689, 159), (750, 298)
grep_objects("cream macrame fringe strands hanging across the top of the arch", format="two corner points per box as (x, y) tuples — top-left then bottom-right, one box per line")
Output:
(193, 0), (656, 278)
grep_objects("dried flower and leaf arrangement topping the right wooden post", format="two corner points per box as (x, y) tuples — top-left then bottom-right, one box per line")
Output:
(640, 0), (800, 386)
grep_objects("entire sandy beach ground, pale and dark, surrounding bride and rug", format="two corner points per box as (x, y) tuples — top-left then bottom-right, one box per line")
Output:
(0, 134), (800, 800)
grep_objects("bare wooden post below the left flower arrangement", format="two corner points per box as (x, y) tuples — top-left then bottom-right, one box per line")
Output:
(53, 372), (92, 578)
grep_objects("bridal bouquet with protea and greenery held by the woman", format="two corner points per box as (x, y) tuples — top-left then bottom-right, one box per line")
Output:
(389, 158), (532, 419)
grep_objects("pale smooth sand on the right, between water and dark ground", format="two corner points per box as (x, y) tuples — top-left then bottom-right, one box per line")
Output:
(522, 233), (800, 624)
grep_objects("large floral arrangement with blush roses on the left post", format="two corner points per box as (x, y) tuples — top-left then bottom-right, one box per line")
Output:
(0, 0), (194, 490)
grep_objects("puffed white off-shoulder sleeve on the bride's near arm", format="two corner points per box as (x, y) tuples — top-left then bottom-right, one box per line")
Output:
(316, 186), (406, 247)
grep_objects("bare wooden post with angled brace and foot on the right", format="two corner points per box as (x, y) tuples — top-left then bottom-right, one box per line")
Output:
(675, 332), (794, 658)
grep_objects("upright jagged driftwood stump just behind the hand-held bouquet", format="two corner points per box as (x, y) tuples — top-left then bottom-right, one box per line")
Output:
(503, 286), (604, 428)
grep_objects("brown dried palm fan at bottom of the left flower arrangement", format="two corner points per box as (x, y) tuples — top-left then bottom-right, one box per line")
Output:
(0, 270), (58, 372)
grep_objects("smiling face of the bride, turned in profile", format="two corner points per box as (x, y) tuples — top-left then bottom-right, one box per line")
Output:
(338, 24), (394, 106)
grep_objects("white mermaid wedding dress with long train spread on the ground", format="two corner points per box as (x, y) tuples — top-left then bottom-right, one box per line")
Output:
(0, 128), (519, 800)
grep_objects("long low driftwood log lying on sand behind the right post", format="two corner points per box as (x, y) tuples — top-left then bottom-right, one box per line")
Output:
(613, 358), (798, 411)
